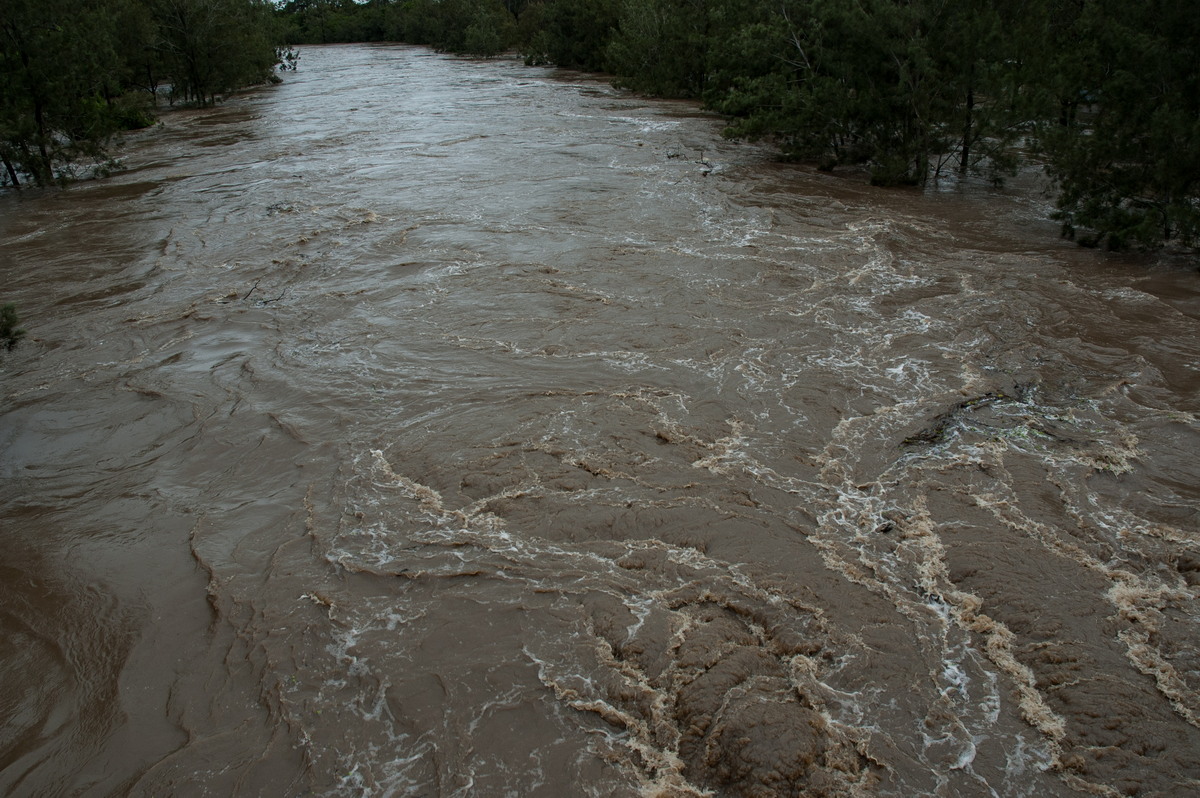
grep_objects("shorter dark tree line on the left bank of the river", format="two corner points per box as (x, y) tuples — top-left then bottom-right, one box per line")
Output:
(0, 0), (281, 186)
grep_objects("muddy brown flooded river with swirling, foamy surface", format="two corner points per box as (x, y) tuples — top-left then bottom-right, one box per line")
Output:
(0, 46), (1200, 798)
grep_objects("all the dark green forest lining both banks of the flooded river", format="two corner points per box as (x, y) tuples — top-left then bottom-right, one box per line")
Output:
(0, 0), (1200, 248)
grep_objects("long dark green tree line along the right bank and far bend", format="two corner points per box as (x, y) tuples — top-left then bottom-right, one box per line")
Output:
(277, 0), (1200, 248)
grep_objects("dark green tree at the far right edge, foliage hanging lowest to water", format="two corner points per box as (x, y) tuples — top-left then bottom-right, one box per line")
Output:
(1039, 0), (1200, 248)
